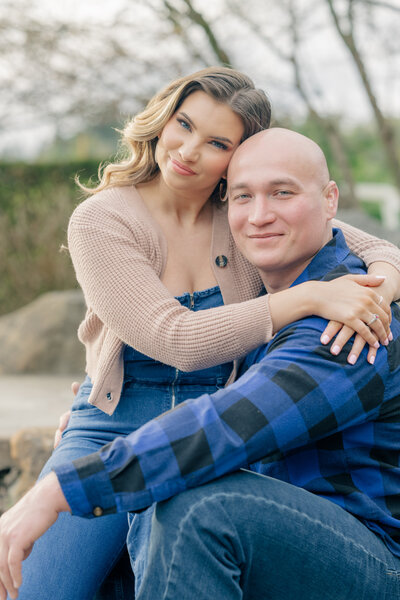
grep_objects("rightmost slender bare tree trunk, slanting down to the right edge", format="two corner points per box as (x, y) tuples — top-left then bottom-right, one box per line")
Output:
(326, 0), (400, 192)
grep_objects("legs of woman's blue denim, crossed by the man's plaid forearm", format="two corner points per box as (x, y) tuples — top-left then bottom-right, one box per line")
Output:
(13, 378), (134, 600)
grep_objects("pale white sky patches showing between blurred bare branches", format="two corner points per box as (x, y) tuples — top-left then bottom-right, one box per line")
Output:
(0, 0), (400, 155)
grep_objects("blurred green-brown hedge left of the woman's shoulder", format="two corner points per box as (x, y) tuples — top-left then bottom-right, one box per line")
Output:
(0, 161), (98, 314)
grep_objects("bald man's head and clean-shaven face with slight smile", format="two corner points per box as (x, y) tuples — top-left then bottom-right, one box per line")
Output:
(228, 130), (337, 291)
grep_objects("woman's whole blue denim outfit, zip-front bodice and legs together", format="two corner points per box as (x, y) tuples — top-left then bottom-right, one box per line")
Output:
(19, 286), (232, 600)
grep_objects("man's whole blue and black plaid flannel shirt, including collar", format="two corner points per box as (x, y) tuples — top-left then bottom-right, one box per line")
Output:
(55, 230), (400, 556)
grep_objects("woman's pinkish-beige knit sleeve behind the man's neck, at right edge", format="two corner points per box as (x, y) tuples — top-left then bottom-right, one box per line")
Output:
(333, 219), (400, 271)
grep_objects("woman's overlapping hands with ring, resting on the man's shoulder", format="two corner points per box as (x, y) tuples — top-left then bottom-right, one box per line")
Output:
(321, 275), (395, 364)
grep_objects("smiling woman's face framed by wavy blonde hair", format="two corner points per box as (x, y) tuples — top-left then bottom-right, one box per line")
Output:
(156, 91), (244, 196)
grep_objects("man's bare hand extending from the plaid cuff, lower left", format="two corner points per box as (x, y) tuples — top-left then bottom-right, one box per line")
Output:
(0, 473), (70, 600)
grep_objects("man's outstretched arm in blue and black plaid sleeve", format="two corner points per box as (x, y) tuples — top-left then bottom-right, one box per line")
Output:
(55, 318), (386, 517)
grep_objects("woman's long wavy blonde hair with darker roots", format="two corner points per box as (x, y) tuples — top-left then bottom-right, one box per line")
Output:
(77, 67), (271, 198)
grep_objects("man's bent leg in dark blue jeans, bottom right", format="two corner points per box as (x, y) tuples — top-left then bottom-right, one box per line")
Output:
(134, 471), (400, 600)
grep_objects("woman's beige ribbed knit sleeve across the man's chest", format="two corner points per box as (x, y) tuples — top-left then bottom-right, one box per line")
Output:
(68, 190), (272, 371)
